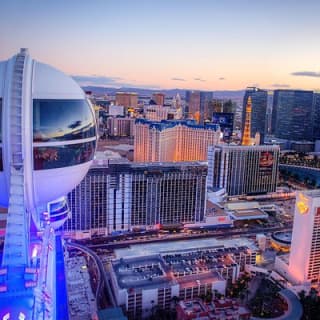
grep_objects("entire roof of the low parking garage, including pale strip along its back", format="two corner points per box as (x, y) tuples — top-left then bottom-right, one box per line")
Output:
(111, 238), (256, 290)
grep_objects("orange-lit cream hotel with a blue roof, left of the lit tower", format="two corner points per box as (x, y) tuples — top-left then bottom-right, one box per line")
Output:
(134, 119), (220, 162)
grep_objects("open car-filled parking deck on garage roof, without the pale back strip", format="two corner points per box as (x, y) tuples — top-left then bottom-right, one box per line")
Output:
(112, 248), (230, 289)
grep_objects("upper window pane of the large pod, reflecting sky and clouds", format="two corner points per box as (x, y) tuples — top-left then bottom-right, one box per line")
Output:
(33, 99), (96, 142)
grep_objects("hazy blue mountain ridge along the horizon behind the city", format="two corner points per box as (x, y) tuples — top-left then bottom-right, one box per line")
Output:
(82, 86), (244, 99)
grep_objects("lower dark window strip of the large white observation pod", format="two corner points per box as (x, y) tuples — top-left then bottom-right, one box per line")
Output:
(33, 140), (96, 170)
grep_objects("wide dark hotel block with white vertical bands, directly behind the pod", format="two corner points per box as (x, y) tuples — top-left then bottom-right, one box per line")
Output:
(65, 160), (207, 237)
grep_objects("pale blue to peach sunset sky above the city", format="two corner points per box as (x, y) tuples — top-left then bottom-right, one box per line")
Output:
(0, 0), (320, 90)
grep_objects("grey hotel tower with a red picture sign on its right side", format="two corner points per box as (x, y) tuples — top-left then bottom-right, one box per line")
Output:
(208, 145), (280, 196)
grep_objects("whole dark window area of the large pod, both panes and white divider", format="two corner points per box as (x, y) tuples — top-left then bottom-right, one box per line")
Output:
(33, 99), (96, 170)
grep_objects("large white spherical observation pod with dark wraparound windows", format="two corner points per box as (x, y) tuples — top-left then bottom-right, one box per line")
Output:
(0, 50), (97, 215)
